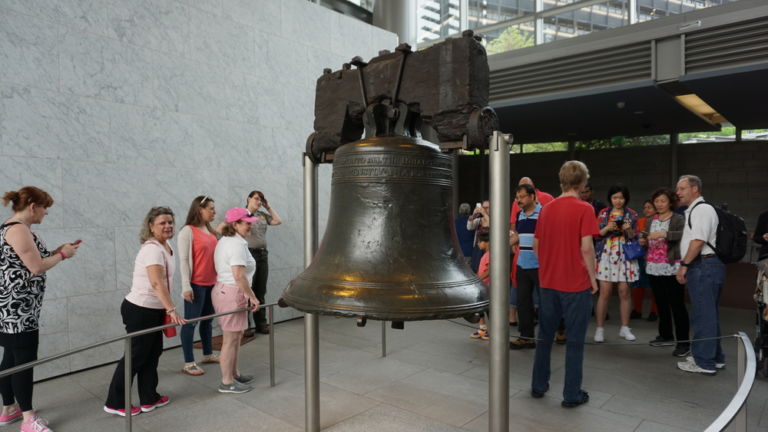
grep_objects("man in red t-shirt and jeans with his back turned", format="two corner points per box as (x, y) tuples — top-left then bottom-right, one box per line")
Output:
(531, 161), (598, 408)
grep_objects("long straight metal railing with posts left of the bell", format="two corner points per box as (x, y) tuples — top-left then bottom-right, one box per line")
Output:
(0, 303), (277, 432)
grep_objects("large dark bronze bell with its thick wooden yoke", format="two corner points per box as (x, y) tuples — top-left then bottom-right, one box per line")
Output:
(281, 34), (492, 321)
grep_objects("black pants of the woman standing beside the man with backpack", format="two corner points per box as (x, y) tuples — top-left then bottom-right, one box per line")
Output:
(648, 275), (689, 340)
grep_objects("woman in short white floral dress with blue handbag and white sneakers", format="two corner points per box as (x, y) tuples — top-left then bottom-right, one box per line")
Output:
(595, 184), (641, 342)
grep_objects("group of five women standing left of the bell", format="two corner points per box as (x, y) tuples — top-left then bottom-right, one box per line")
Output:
(0, 186), (281, 432)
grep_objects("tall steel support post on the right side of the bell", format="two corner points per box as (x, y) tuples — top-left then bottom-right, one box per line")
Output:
(488, 131), (510, 432)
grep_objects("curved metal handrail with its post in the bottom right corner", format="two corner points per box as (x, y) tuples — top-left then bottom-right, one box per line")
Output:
(705, 332), (757, 432)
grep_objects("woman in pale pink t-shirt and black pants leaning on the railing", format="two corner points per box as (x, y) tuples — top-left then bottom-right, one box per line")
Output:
(104, 207), (186, 416)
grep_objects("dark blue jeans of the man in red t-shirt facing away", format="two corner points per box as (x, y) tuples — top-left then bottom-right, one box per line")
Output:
(531, 288), (592, 402)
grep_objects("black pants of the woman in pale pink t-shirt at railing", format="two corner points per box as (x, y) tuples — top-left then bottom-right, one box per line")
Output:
(105, 300), (165, 409)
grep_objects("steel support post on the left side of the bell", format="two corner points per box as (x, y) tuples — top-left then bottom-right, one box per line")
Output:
(304, 155), (320, 432)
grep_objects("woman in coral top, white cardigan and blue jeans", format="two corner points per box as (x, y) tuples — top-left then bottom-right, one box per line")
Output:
(177, 195), (219, 376)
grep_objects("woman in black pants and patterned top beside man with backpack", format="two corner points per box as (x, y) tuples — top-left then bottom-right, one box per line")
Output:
(645, 188), (690, 357)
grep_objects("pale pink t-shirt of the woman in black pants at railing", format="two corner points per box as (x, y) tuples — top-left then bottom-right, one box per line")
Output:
(125, 240), (176, 309)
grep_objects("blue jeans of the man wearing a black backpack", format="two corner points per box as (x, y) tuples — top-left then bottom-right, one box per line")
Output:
(686, 257), (725, 370)
